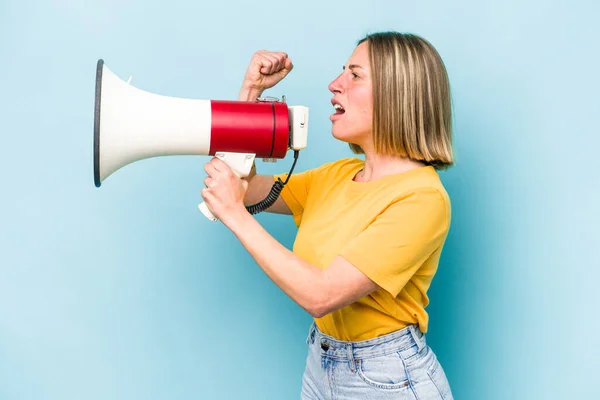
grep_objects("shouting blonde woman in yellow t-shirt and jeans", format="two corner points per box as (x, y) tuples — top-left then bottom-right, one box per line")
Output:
(202, 32), (453, 400)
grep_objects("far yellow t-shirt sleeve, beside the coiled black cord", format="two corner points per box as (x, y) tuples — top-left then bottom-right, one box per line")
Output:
(273, 163), (333, 226)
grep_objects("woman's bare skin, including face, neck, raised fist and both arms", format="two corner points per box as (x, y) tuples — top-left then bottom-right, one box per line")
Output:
(201, 43), (422, 318)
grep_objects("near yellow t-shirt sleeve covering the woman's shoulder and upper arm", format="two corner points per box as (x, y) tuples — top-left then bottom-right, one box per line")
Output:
(340, 189), (450, 297)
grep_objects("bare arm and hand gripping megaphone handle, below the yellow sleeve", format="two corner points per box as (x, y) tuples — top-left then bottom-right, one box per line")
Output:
(202, 158), (378, 317)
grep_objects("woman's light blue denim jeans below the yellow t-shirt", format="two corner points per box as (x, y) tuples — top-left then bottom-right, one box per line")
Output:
(301, 322), (453, 400)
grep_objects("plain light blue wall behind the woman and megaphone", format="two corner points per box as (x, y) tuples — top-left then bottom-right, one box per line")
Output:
(0, 0), (600, 400)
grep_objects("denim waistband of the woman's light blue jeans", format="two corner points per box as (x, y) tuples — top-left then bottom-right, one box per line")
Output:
(307, 321), (426, 361)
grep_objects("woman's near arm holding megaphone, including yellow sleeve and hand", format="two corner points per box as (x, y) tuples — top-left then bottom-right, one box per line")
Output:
(202, 159), (450, 317)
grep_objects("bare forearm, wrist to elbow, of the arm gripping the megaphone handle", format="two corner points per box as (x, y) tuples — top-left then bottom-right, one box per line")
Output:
(224, 213), (328, 317)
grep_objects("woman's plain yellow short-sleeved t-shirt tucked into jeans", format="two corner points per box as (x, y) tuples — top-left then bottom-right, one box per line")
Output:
(275, 158), (451, 341)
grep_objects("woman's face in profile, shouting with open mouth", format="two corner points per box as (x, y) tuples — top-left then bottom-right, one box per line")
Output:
(329, 42), (373, 149)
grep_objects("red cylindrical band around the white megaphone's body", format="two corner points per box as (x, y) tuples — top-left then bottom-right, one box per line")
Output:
(209, 100), (290, 158)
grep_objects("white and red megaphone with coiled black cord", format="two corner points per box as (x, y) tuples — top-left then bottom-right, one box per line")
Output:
(94, 59), (308, 221)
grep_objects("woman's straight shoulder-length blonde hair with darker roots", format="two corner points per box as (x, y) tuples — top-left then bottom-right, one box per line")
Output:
(350, 32), (454, 169)
